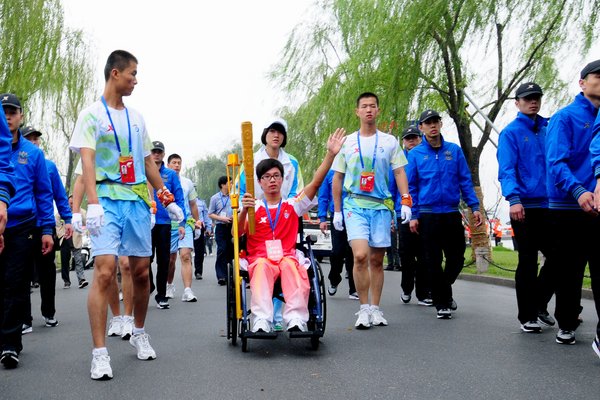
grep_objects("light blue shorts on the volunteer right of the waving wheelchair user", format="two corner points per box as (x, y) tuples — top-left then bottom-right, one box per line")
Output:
(344, 208), (392, 248)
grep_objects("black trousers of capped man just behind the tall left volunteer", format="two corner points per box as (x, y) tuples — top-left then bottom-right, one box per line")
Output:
(148, 224), (171, 301)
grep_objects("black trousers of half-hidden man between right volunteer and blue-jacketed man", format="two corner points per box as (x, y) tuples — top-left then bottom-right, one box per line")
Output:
(397, 219), (431, 300)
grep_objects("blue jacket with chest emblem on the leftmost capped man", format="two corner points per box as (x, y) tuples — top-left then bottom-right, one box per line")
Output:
(6, 133), (56, 235)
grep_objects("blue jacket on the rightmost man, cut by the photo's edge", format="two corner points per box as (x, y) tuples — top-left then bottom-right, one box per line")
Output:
(546, 93), (598, 210)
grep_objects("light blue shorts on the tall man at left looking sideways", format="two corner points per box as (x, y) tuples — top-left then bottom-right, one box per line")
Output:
(91, 197), (152, 257)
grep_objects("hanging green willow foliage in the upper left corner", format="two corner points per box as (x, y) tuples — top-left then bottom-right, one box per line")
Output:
(0, 0), (95, 190)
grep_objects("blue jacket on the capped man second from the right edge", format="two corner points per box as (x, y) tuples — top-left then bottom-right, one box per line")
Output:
(496, 112), (548, 208)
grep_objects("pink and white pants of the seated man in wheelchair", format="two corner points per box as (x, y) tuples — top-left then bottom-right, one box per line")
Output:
(248, 257), (310, 324)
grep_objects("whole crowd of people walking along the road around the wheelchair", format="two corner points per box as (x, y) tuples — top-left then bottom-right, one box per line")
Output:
(0, 50), (600, 380)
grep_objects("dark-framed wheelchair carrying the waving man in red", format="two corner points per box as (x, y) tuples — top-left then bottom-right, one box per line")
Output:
(227, 232), (327, 352)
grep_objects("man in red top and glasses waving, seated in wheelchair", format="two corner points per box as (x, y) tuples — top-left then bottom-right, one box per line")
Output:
(238, 128), (346, 333)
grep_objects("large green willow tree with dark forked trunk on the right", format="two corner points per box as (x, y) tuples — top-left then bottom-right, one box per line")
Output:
(271, 0), (600, 256)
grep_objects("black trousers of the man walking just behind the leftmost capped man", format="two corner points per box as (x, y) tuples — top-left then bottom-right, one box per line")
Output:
(25, 227), (58, 325)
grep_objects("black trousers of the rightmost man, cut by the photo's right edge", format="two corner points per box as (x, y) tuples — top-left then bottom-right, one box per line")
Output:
(549, 210), (600, 335)
